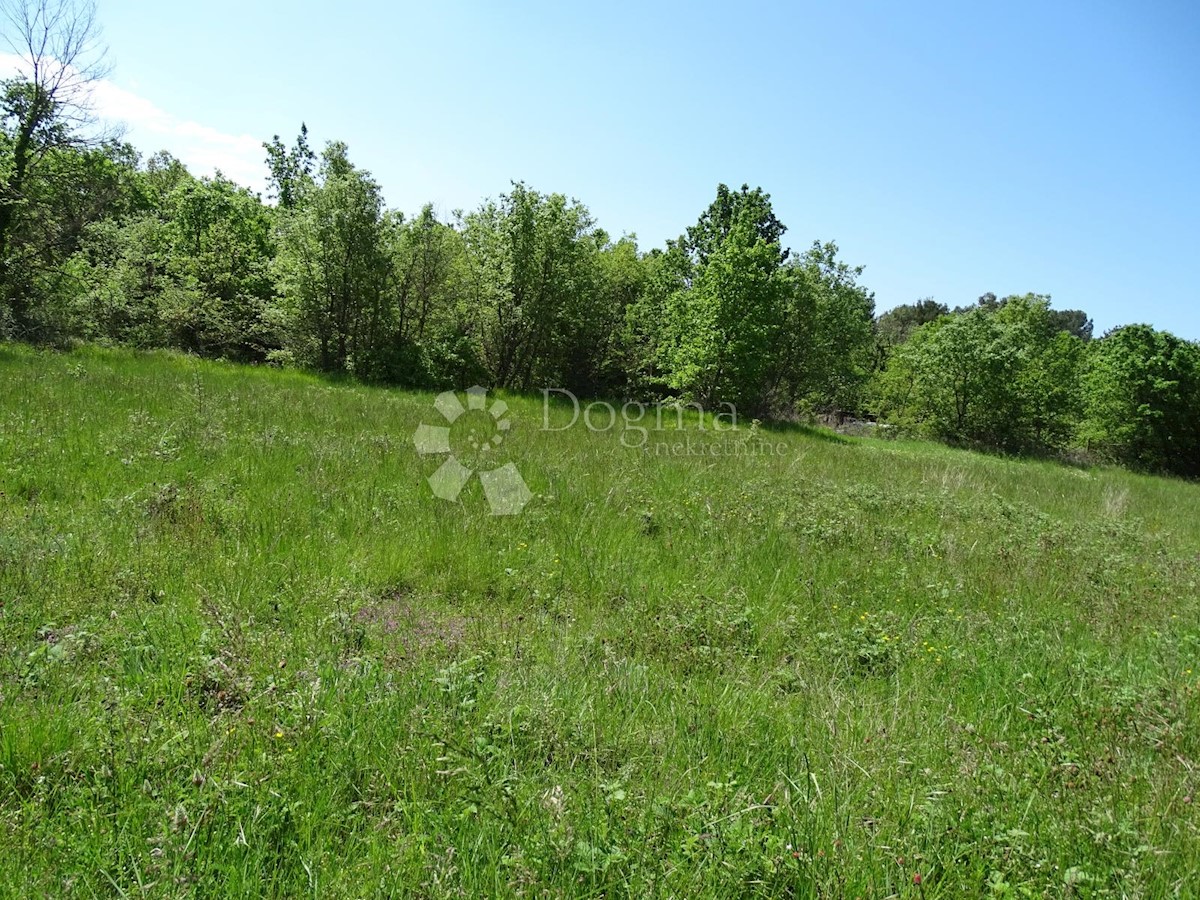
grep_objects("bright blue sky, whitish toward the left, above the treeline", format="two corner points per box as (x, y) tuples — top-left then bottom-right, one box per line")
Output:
(11, 0), (1200, 340)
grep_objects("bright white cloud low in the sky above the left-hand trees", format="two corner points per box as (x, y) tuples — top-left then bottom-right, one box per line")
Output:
(0, 53), (264, 191)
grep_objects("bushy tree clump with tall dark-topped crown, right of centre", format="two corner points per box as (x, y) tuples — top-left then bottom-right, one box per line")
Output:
(648, 185), (874, 416)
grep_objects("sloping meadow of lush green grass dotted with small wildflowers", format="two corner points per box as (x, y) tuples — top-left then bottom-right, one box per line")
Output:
(0, 346), (1200, 898)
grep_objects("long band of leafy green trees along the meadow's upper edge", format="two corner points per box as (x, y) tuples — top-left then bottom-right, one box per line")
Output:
(0, 2), (1200, 478)
